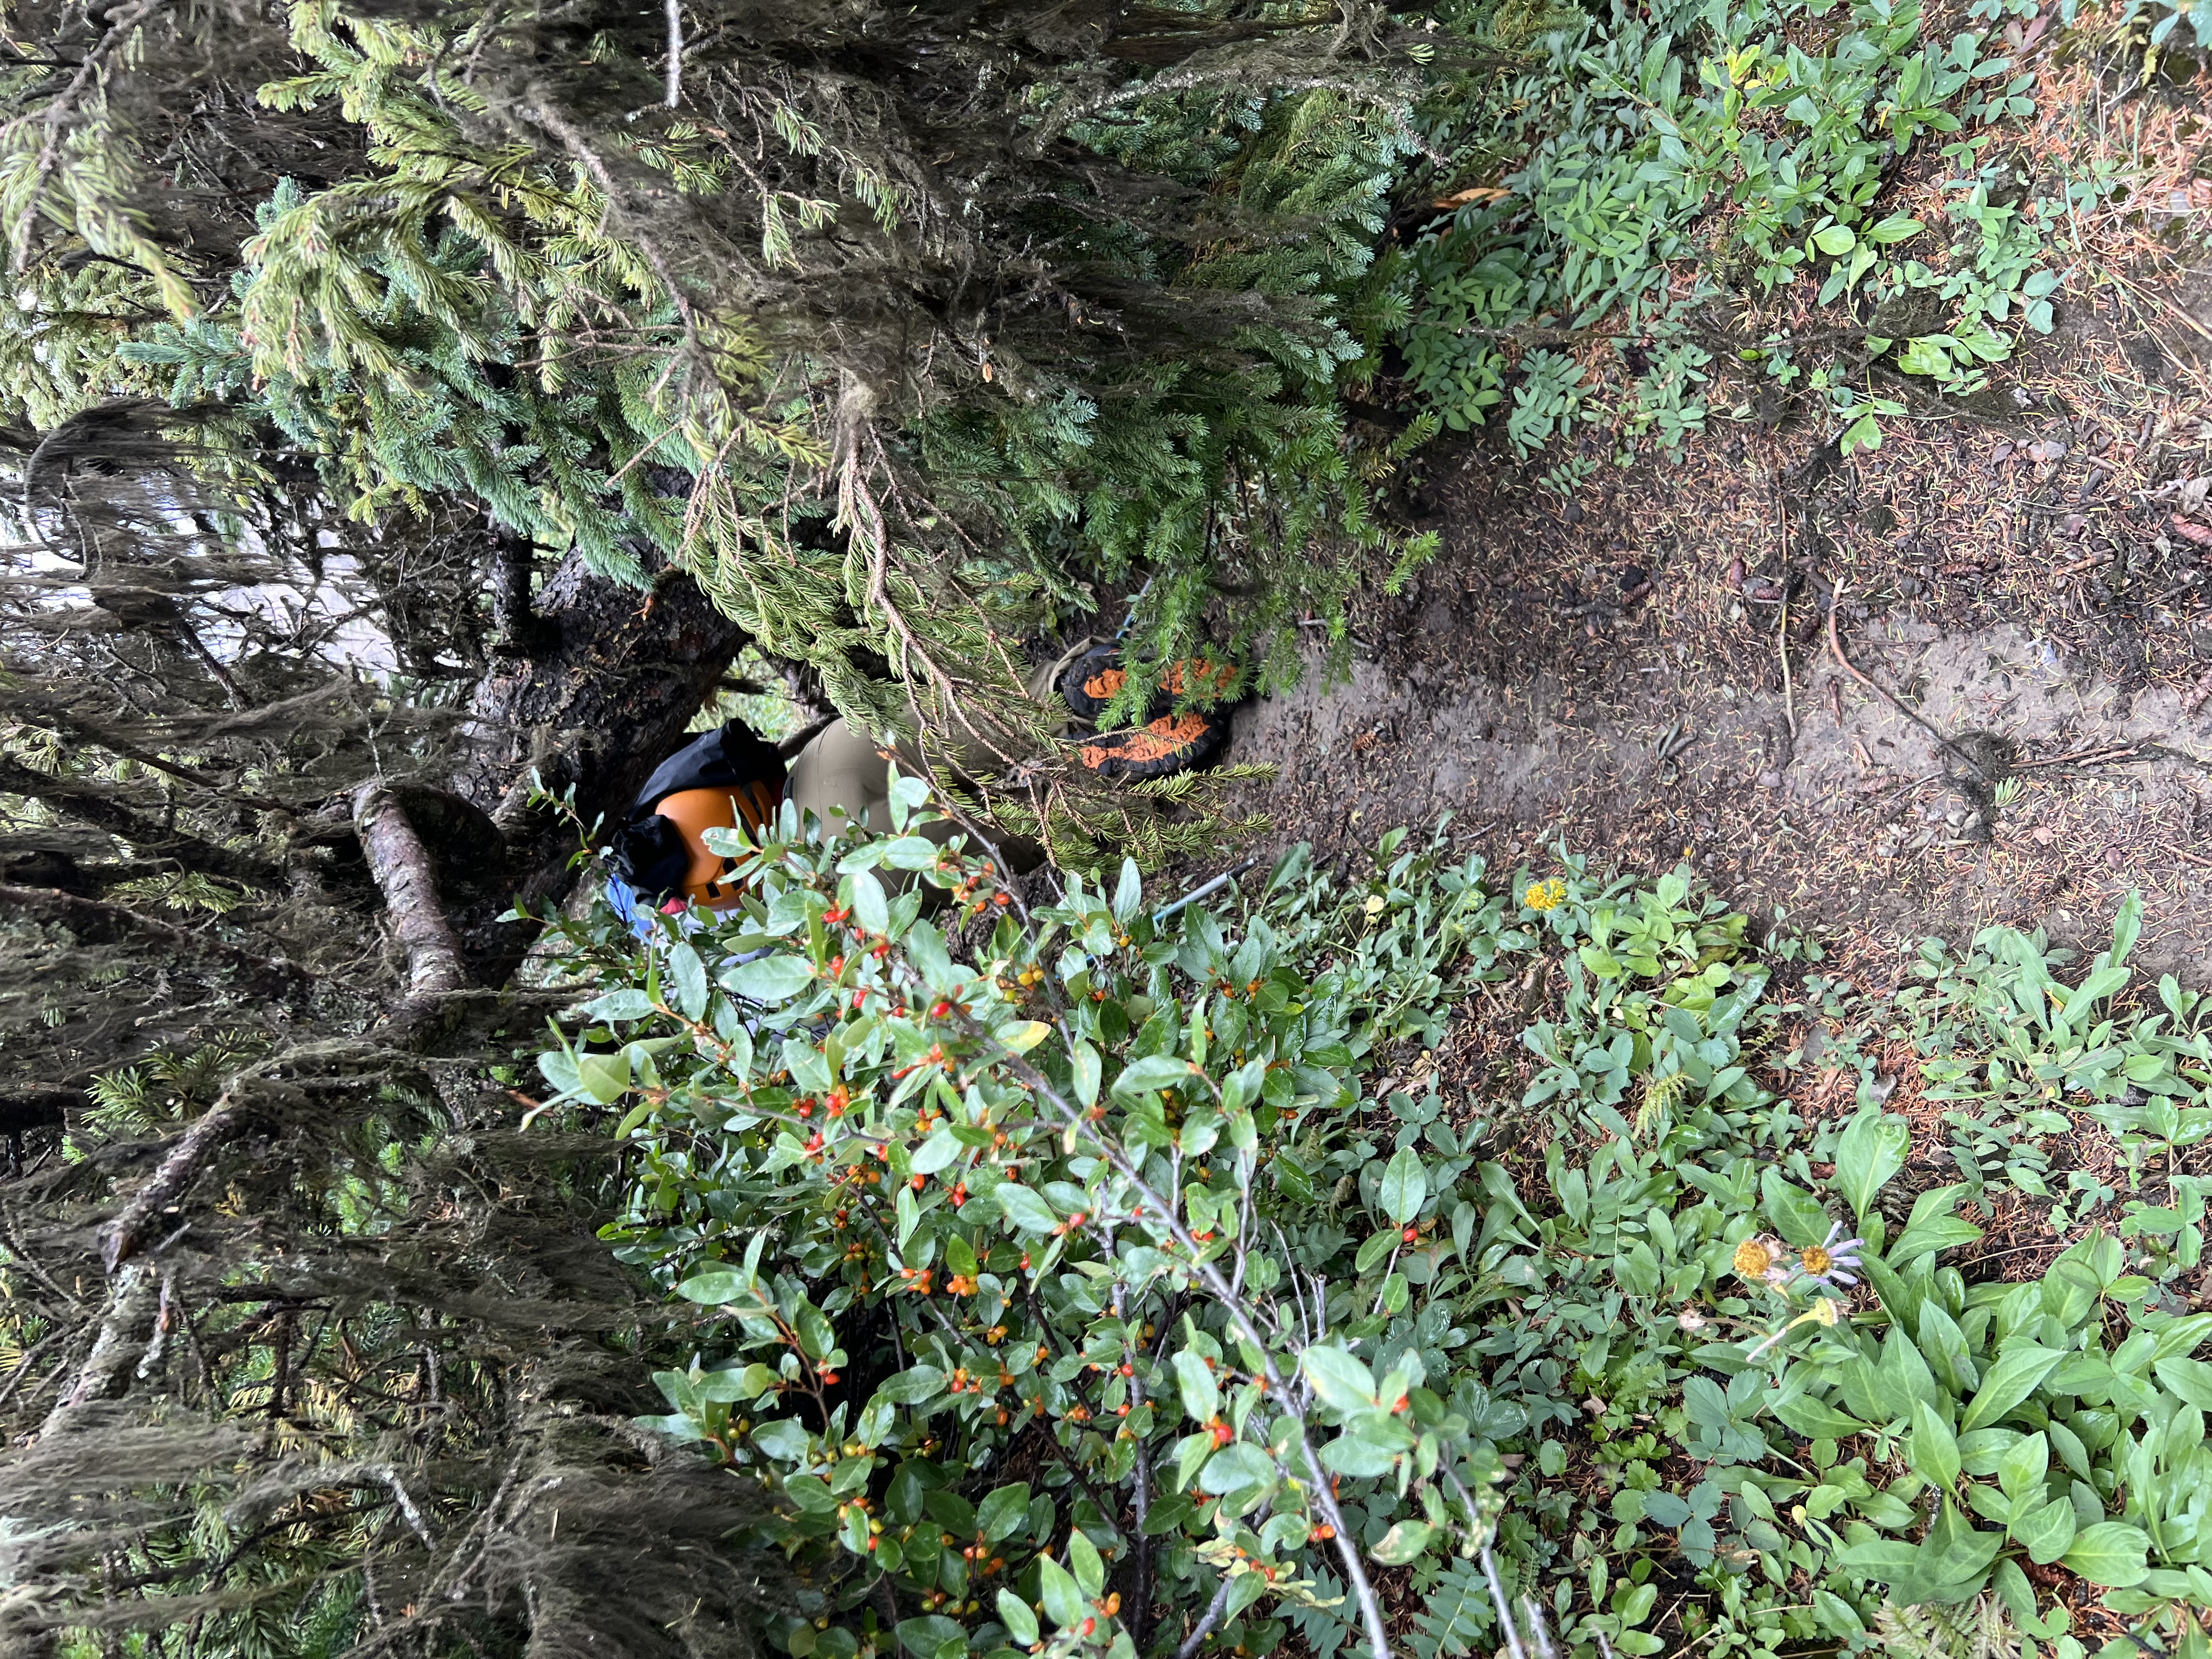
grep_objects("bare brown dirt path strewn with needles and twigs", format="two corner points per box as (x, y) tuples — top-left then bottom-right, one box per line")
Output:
(1230, 261), (2212, 982)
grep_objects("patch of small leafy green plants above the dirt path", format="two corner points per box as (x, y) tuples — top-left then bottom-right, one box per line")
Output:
(1385, 0), (2064, 456)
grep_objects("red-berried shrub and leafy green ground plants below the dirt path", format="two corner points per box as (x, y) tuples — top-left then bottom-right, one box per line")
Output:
(542, 783), (2212, 1659)
